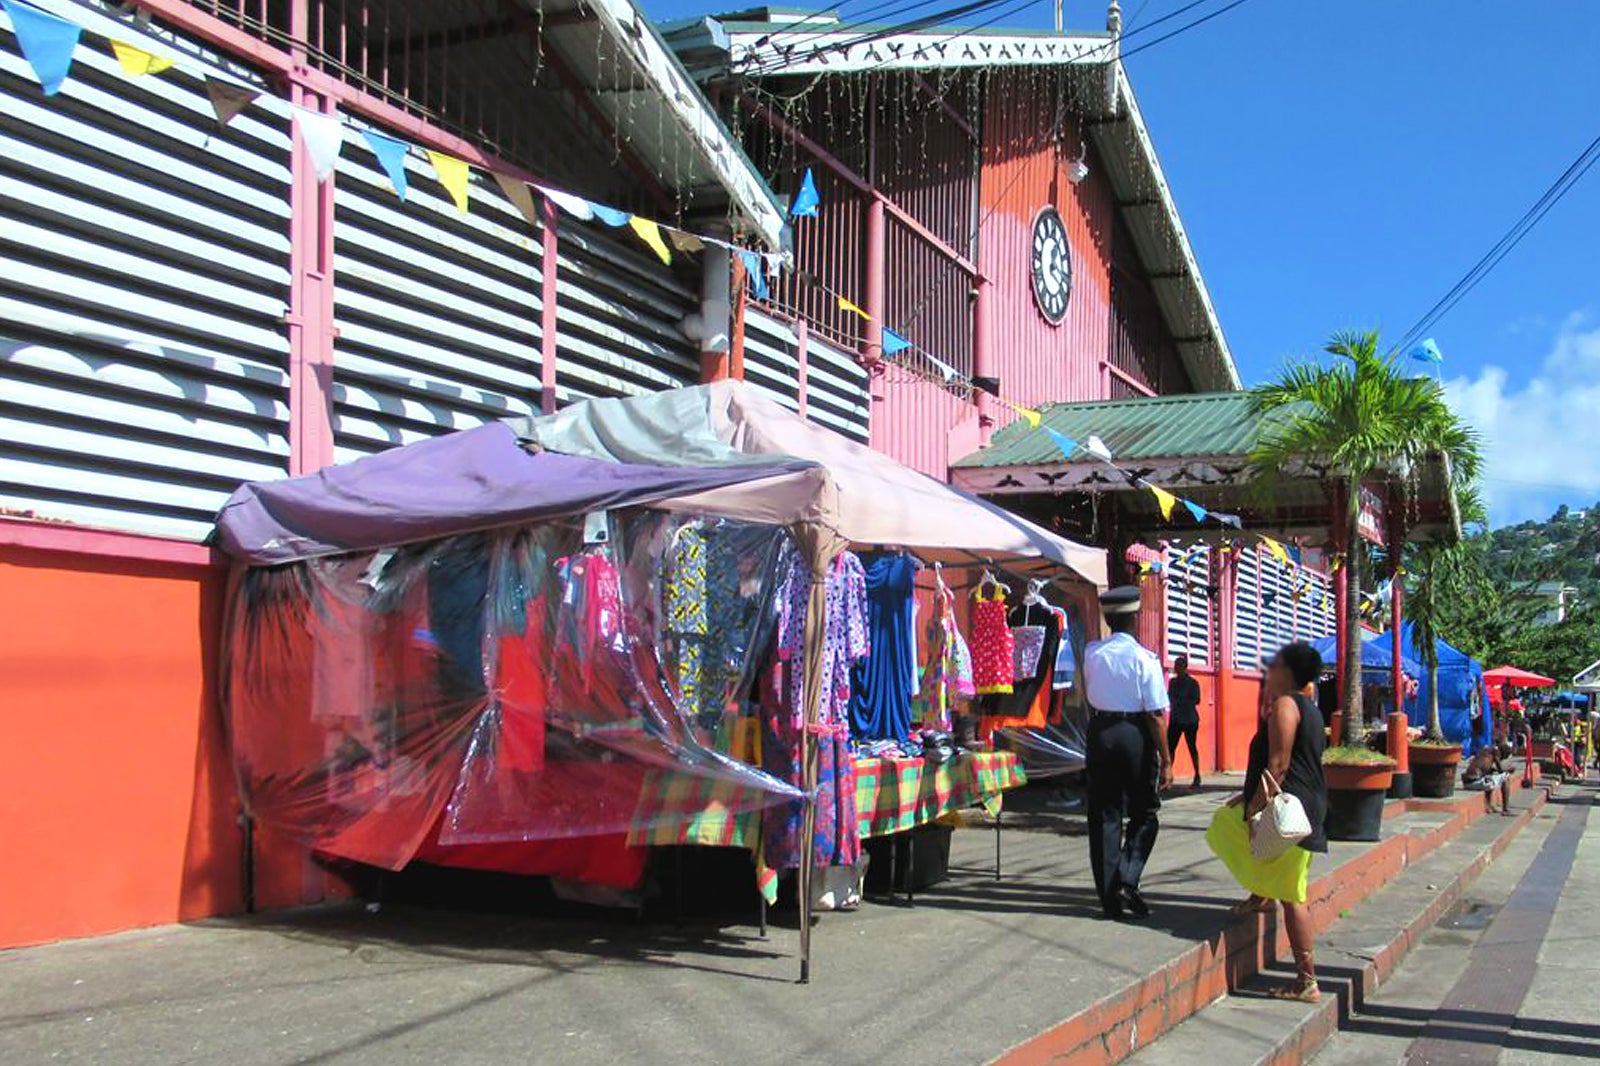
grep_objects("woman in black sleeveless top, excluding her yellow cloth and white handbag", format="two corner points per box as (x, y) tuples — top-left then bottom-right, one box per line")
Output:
(1234, 642), (1328, 1004)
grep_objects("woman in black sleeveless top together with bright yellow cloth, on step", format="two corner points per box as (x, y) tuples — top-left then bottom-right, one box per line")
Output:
(1206, 642), (1328, 1004)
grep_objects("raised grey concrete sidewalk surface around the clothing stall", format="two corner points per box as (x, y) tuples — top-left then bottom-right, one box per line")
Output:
(0, 779), (1497, 1066)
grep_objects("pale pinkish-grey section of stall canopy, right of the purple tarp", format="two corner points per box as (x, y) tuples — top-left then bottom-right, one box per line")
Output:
(514, 381), (1106, 587)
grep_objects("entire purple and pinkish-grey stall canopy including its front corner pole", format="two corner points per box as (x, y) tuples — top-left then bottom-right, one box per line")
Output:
(219, 383), (1106, 980)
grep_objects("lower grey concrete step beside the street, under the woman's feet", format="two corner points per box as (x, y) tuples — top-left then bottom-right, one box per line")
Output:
(1125, 771), (1549, 1066)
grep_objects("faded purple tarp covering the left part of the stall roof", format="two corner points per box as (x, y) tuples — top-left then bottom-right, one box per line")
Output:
(218, 423), (811, 565)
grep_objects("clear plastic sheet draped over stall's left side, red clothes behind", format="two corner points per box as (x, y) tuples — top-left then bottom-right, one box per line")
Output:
(227, 509), (802, 869)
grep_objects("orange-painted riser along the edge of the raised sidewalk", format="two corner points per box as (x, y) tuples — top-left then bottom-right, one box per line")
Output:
(992, 768), (1544, 1066)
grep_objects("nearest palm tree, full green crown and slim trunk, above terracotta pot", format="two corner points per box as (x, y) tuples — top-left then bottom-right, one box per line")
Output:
(1251, 331), (1480, 744)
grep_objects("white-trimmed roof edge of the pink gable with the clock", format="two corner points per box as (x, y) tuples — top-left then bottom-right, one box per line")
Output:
(661, 6), (1240, 389)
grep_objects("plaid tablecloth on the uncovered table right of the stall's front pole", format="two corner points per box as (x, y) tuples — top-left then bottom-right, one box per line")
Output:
(856, 751), (1027, 837)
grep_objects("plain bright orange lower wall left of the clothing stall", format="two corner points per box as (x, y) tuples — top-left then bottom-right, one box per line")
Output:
(0, 547), (243, 948)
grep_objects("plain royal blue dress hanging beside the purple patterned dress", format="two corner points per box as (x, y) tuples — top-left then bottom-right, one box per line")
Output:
(850, 555), (917, 739)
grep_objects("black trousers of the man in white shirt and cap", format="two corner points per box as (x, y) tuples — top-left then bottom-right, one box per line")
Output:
(1086, 714), (1162, 906)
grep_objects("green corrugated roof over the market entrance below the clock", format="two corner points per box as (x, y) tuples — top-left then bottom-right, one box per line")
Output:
(955, 392), (1259, 466)
